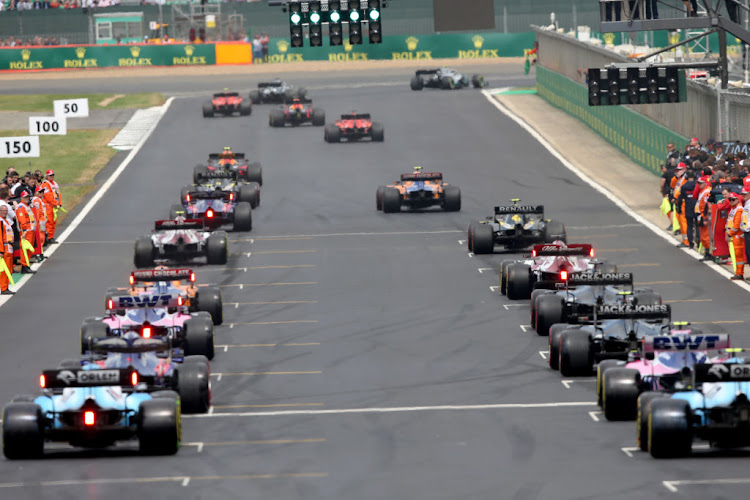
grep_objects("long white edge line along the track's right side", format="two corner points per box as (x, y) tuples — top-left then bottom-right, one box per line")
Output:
(482, 89), (750, 292)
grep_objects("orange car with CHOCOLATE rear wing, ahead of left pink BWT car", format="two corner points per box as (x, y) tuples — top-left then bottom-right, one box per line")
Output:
(105, 266), (224, 325)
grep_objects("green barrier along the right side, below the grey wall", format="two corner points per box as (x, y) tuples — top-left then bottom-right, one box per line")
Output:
(536, 66), (688, 174)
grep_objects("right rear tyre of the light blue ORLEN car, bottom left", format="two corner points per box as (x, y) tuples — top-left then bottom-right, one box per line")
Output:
(138, 398), (182, 455)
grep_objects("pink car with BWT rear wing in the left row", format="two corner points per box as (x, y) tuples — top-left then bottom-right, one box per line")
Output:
(80, 287), (214, 359)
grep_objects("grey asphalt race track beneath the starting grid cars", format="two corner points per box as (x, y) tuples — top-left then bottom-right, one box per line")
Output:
(0, 65), (750, 500)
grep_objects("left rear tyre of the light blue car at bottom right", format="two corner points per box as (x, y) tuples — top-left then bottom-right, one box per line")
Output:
(648, 399), (692, 458)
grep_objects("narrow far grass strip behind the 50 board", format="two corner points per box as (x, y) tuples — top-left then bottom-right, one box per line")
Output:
(0, 92), (166, 113)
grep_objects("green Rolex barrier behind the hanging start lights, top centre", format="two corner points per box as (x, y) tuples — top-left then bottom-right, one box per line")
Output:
(262, 30), (535, 63)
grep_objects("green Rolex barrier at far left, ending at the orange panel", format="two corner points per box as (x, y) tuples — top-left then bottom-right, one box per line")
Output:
(0, 44), (216, 71)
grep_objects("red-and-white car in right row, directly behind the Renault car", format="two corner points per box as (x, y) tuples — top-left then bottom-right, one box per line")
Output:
(500, 241), (602, 300)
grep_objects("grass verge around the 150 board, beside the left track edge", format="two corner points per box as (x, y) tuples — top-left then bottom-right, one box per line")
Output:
(0, 129), (118, 223)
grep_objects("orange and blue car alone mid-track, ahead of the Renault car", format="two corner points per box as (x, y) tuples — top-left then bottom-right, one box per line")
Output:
(375, 167), (461, 213)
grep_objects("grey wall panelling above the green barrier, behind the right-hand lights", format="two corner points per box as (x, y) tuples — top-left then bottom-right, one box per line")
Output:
(534, 27), (750, 142)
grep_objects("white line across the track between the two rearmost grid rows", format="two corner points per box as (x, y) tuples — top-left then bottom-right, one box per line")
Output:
(182, 401), (596, 419)
